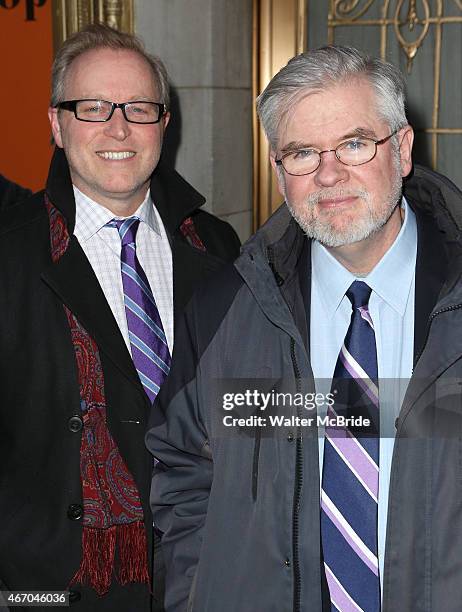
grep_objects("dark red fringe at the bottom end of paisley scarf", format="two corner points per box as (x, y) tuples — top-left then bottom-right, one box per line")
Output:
(70, 521), (150, 595)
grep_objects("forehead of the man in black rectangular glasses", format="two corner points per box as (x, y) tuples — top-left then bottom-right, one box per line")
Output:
(65, 48), (157, 102)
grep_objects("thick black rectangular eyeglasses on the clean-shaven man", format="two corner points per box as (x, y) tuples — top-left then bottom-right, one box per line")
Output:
(56, 99), (167, 123)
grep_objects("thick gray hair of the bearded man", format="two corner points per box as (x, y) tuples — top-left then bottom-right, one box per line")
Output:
(257, 45), (407, 147)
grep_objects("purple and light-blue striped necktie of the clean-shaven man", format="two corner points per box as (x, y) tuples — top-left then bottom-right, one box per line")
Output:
(108, 217), (171, 402)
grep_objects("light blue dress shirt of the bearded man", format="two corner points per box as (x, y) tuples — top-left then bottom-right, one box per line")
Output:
(310, 198), (417, 584)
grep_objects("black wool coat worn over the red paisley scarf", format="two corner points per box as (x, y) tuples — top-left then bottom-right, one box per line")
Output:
(0, 149), (239, 612)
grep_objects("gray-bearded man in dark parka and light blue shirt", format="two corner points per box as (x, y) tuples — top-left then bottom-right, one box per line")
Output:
(147, 46), (462, 612)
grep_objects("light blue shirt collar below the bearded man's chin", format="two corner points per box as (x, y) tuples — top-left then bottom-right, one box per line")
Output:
(311, 197), (417, 318)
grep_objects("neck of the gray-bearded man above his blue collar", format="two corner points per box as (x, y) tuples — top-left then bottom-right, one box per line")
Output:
(326, 206), (403, 276)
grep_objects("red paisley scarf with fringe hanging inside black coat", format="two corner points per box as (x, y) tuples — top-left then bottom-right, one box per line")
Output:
(45, 196), (150, 595)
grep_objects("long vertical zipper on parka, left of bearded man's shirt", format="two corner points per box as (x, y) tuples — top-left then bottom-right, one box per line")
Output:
(290, 338), (303, 612)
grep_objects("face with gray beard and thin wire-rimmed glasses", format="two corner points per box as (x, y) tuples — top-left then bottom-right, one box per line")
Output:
(271, 79), (412, 253)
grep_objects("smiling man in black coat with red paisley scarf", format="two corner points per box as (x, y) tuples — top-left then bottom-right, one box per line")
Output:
(0, 25), (239, 612)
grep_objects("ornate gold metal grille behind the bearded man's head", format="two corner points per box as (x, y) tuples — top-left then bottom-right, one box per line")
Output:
(324, 0), (462, 185)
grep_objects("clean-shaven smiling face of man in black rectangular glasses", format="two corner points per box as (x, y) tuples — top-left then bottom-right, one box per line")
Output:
(48, 48), (169, 216)
